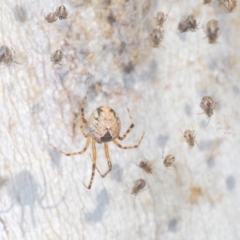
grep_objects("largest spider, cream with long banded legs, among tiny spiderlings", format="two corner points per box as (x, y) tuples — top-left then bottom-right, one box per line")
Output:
(51, 94), (144, 189)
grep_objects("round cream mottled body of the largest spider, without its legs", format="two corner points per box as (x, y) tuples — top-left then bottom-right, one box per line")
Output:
(88, 106), (121, 143)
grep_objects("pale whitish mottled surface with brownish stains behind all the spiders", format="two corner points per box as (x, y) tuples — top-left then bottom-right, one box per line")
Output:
(0, 0), (240, 240)
